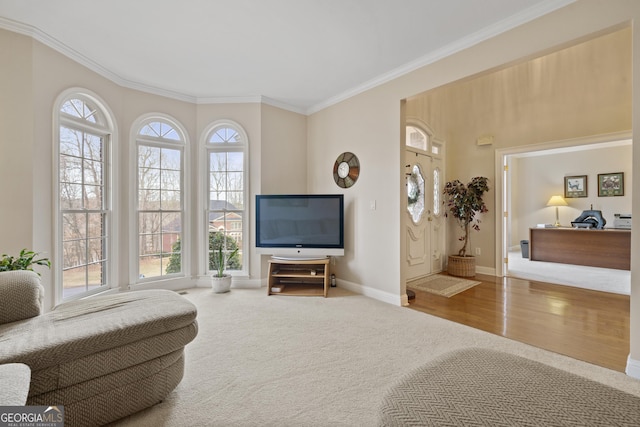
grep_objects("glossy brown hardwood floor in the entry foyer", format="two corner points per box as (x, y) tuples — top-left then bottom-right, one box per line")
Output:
(409, 274), (630, 372)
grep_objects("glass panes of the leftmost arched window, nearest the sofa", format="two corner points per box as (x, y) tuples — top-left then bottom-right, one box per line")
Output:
(54, 94), (112, 300)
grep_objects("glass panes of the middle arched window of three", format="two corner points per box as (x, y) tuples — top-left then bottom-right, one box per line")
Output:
(136, 118), (185, 280)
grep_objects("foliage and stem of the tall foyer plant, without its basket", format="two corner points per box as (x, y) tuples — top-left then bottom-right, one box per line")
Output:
(443, 176), (489, 256)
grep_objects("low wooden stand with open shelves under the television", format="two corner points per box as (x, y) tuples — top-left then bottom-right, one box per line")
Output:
(267, 258), (329, 298)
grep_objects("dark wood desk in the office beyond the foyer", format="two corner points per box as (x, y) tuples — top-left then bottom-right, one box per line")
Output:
(529, 227), (631, 270)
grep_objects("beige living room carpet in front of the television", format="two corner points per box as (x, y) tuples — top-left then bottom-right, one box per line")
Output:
(110, 288), (640, 427)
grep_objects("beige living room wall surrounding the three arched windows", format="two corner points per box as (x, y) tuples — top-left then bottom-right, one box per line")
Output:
(0, 30), (307, 308)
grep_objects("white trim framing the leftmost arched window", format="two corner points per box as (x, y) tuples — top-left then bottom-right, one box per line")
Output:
(51, 87), (120, 306)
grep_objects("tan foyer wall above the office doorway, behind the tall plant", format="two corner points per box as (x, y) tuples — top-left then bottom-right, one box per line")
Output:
(406, 28), (631, 271)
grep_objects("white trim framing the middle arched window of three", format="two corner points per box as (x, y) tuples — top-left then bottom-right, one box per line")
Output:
(129, 113), (193, 289)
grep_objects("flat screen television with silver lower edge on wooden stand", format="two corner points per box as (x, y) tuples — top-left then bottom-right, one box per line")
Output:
(256, 194), (344, 259)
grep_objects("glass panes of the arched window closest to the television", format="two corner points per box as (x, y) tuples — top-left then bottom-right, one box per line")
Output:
(206, 122), (248, 274)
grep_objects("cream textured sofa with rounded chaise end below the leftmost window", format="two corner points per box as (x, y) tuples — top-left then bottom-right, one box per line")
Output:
(0, 271), (198, 426)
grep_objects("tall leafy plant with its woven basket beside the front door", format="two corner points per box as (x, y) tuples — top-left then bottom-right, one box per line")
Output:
(443, 176), (489, 276)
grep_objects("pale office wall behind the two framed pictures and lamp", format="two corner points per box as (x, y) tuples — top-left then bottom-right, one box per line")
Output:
(510, 144), (633, 246)
